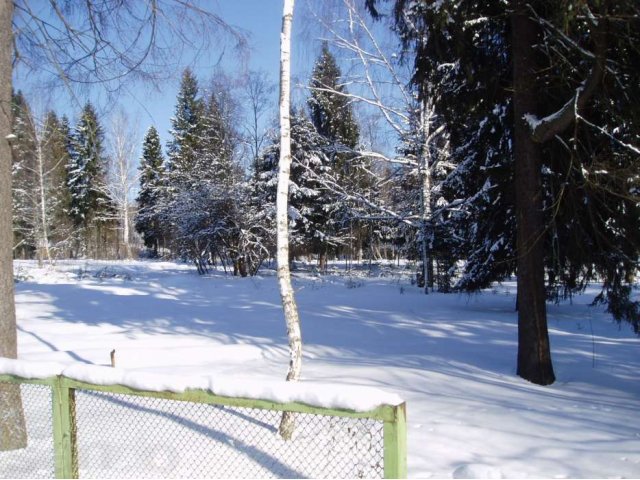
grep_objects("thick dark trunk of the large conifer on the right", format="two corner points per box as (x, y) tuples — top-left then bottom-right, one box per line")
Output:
(511, 0), (555, 385)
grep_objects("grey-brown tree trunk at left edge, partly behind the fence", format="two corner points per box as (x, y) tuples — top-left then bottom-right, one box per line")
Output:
(0, 0), (27, 451)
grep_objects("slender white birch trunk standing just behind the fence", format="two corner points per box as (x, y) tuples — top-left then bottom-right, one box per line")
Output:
(276, 0), (302, 440)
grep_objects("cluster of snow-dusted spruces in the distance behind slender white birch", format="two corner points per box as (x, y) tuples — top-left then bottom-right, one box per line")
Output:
(136, 55), (376, 276)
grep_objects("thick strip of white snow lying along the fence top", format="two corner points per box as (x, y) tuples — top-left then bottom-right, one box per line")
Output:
(0, 358), (404, 412)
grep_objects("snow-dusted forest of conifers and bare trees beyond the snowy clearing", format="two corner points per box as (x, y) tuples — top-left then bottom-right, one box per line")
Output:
(5, 0), (640, 384)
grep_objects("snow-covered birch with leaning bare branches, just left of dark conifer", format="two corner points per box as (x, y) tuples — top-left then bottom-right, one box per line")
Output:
(311, 0), (453, 286)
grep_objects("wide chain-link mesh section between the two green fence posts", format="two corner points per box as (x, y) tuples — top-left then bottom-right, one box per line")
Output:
(76, 390), (384, 478)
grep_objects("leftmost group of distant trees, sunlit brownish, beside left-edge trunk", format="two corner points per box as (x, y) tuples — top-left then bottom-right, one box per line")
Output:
(11, 92), (121, 260)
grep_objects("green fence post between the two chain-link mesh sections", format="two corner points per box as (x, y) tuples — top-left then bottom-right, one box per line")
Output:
(53, 376), (78, 478)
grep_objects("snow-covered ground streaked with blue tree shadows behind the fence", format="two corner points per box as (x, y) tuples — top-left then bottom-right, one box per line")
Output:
(7, 262), (640, 478)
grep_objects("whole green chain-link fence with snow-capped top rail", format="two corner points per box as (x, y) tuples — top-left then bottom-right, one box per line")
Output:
(0, 359), (407, 478)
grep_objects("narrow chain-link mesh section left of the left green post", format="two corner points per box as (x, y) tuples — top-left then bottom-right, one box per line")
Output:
(0, 383), (55, 478)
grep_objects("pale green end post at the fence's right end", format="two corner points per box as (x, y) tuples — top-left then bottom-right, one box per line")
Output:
(384, 403), (407, 478)
